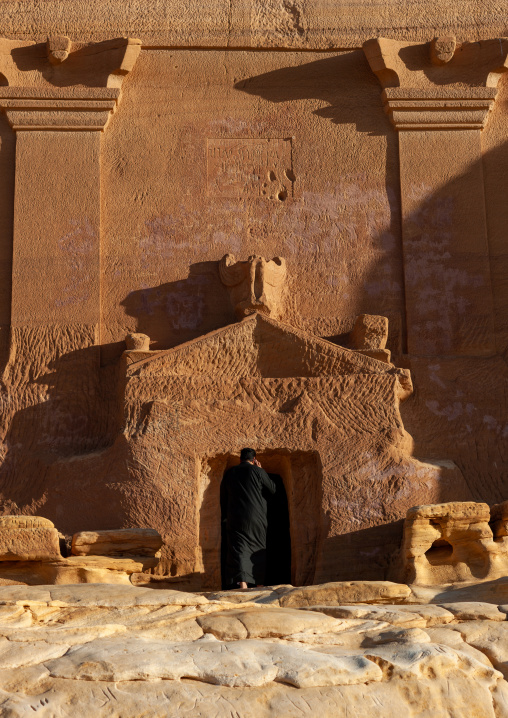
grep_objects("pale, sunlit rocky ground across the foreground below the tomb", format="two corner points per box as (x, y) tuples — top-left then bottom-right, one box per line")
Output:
(0, 579), (508, 718)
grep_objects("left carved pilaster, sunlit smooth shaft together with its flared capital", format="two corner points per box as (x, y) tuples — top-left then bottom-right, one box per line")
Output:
(0, 38), (141, 346)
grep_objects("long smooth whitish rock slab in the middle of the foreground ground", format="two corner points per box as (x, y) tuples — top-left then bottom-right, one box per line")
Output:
(45, 638), (382, 688)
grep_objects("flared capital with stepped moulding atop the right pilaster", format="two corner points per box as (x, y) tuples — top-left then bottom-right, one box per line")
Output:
(363, 36), (508, 130)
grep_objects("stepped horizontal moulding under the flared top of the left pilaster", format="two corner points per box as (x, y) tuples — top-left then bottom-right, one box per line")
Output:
(0, 87), (120, 132)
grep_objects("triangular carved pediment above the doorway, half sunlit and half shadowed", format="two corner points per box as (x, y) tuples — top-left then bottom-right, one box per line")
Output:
(127, 314), (397, 380)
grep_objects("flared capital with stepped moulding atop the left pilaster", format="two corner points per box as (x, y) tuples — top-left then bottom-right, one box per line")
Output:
(0, 38), (141, 132)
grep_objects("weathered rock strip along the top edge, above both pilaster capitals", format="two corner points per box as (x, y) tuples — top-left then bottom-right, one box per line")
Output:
(0, 0), (505, 51)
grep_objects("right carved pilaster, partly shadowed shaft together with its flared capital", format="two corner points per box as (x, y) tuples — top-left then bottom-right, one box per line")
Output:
(364, 37), (508, 355)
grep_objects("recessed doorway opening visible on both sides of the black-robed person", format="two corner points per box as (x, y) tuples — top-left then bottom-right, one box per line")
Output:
(199, 449), (322, 590)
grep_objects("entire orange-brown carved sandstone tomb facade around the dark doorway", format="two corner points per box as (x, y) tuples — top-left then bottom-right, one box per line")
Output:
(0, 8), (508, 608)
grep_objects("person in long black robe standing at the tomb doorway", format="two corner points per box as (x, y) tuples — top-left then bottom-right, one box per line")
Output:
(220, 449), (276, 588)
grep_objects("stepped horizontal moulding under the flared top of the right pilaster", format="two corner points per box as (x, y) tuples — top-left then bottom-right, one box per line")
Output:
(383, 87), (497, 130)
